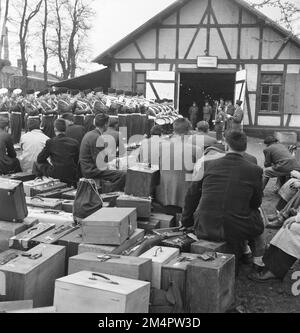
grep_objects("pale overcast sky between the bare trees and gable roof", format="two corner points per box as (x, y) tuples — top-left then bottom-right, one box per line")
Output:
(11, 0), (300, 73)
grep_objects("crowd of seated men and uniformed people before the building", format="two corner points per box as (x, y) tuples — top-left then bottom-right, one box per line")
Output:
(0, 85), (300, 282)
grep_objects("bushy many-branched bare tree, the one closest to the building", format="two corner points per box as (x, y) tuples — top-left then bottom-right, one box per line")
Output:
(50, 0), (95, 79)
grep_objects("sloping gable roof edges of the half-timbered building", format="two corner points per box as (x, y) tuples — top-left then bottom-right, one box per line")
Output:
(93, 0), (300, 64)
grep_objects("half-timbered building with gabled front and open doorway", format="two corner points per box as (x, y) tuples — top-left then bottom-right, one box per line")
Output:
(94, 0), (300, 133)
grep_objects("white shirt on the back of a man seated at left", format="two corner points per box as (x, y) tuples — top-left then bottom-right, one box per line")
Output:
(20, 130), (49, 172)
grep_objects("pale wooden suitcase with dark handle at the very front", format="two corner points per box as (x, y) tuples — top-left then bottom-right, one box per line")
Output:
(54, 271), (150, 313)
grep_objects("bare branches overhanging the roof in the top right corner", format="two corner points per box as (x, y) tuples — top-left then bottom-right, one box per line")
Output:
(251, 0), (300, 34)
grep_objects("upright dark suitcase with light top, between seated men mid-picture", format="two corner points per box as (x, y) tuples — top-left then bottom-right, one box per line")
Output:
(125, 164), (160, 198)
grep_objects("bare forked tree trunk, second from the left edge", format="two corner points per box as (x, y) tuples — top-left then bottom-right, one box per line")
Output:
(19, 0), (43, 90)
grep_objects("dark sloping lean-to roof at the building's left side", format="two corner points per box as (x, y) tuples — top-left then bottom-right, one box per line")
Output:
(53, 68), (110, 90)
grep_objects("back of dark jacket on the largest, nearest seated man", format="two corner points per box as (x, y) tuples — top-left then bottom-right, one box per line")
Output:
(196, 154), (263, 240)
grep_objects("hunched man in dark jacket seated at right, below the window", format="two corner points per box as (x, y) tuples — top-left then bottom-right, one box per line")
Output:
(263, 136), (300, 189)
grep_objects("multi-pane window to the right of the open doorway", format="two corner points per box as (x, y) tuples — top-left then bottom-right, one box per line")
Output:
(260, 74), (283, 113)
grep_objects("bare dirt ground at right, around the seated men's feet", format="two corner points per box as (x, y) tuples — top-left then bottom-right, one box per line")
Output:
(235, 139), (300, 313)
